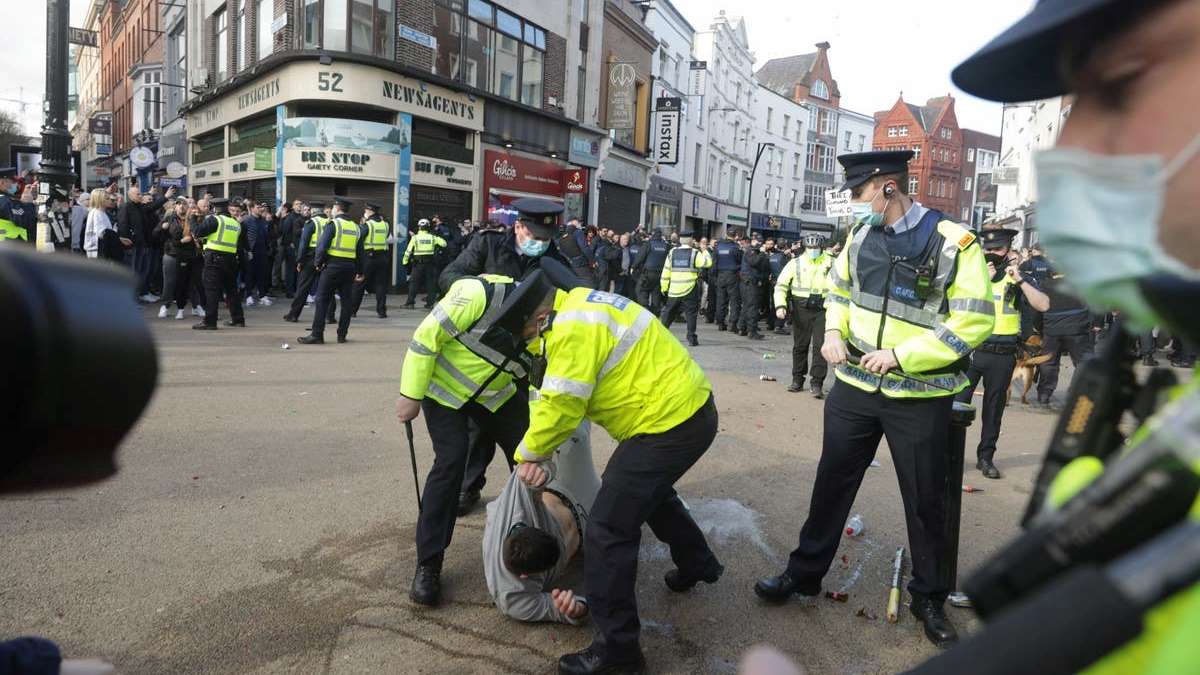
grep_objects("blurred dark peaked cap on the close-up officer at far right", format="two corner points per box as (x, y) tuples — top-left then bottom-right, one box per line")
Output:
(950, 0), (1163, 102)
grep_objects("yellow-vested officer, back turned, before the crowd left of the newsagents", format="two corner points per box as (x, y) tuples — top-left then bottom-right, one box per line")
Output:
(192, 197), (250, 330)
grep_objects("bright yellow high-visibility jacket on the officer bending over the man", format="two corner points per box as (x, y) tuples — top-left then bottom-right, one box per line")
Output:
(515, 288), (713, 461)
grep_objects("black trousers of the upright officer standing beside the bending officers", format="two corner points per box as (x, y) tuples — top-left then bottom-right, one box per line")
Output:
(787, 380), (954, 602)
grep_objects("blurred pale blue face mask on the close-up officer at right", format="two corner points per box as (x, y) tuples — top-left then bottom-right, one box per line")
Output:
(1036, 135), (1200, 330)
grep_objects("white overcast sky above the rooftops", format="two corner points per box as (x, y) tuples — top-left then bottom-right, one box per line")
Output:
(0, 0), (1033, 136)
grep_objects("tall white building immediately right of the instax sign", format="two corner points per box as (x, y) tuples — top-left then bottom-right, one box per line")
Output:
(683, 11), (757, 237)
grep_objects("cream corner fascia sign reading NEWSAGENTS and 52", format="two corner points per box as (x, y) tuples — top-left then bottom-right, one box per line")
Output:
(187, 61), (484, 138)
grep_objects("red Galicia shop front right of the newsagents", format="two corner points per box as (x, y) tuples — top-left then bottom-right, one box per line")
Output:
(484, 149), (588, 225)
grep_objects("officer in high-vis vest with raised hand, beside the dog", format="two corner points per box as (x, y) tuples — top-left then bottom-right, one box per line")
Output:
(958, 228), (1050, 478)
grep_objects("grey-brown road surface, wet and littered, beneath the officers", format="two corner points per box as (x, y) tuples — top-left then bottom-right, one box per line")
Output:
(0, 298), (1069, 674)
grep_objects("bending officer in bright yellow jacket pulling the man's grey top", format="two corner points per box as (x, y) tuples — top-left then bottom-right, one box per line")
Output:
(516, 261), (724, 674)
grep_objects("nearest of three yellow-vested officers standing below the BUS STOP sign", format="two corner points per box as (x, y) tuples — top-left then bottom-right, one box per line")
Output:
(299, 197), (366, 345)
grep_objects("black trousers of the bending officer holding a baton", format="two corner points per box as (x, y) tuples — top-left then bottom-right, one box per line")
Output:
(416, 388), (529, 567)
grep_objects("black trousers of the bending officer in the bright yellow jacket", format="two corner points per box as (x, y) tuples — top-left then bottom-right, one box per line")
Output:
(583, 396), (719, 657)
